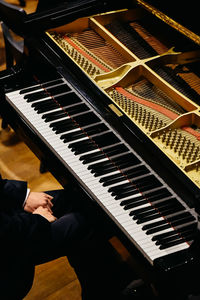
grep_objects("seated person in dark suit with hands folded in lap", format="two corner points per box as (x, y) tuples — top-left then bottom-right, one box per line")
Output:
(0, 172), (134, 300)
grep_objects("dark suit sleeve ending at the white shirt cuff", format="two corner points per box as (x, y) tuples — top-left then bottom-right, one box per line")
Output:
(0, 178), (27, 210)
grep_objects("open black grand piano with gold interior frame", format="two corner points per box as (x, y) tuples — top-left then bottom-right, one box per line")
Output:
(0, 0), (200, 299)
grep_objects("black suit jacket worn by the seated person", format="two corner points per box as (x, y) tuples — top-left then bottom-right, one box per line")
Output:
(0, 176), (50, 300)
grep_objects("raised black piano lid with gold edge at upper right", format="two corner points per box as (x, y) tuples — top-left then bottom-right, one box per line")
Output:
(0, 0), (200, 45)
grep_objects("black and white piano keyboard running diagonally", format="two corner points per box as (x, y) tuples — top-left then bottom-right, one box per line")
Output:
(6, 78), (196, 264)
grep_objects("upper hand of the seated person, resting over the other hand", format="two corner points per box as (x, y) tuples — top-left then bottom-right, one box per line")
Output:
(24, 192), (53, 213)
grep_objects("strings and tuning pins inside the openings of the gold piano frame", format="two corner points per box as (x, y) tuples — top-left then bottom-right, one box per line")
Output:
(48, 14), (200, 188)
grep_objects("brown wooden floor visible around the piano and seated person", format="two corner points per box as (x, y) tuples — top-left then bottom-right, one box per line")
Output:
(0, 0), (81, 300)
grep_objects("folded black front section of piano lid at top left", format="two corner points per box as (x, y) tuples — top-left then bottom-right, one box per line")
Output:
(0, 0), (130, 36)
